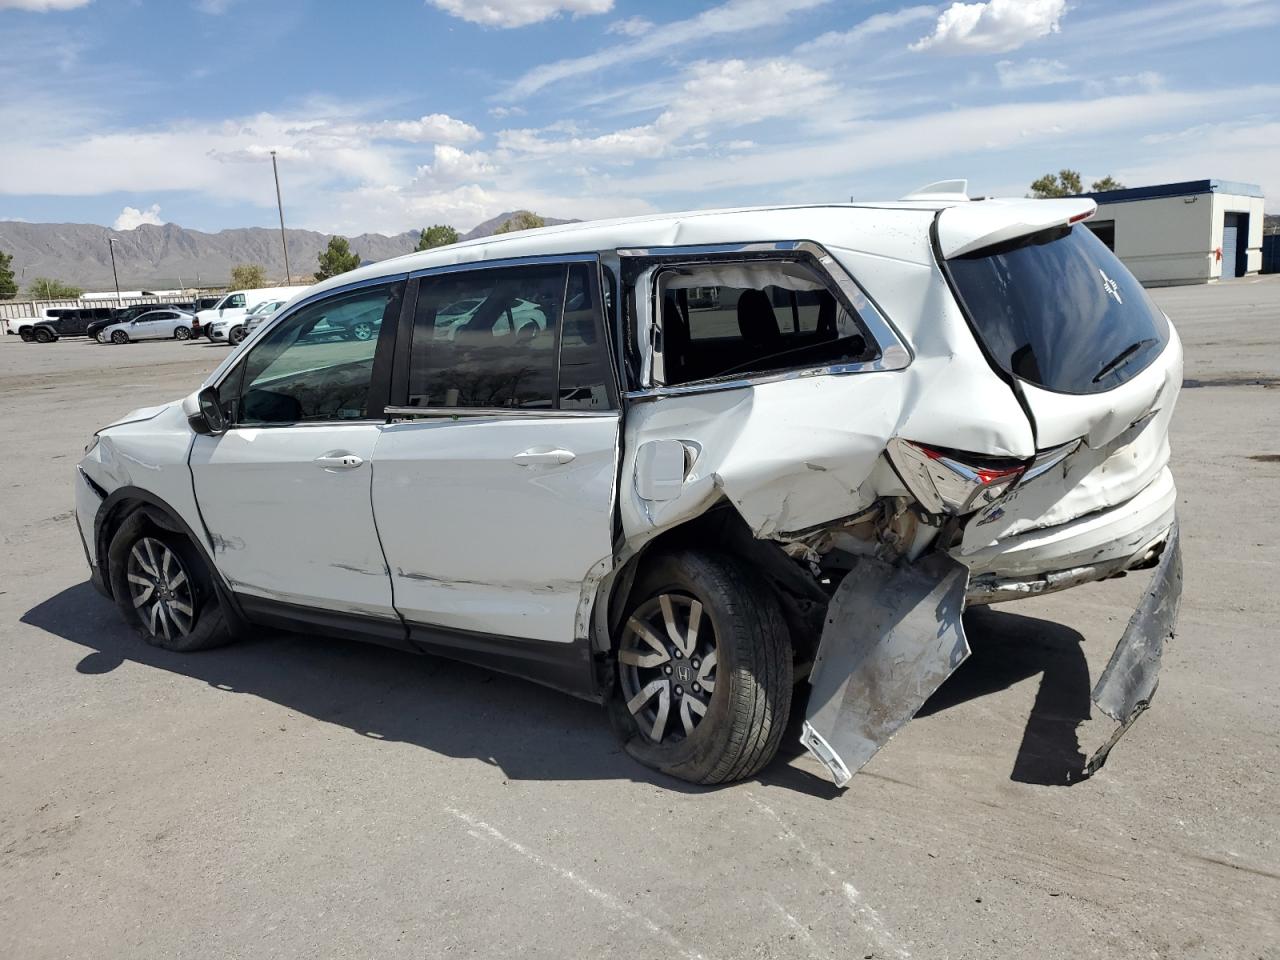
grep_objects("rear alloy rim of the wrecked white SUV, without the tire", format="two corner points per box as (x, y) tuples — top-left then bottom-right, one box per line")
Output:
(618, 594), (719, 744)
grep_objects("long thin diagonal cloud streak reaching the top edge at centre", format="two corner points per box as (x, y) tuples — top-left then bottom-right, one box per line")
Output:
(506, 0), (831, 100)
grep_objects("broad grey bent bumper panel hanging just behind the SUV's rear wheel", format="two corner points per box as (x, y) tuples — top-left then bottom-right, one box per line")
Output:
(800, 553), (969, 787)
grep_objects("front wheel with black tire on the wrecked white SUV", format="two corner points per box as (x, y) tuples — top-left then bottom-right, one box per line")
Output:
(108, 512), (233, 653)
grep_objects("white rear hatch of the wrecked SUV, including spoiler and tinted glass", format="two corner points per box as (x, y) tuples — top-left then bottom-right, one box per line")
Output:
(937, 198), (1183, 539)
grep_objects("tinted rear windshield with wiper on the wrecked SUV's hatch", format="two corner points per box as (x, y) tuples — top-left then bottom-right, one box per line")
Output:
(947, 227), (1169, 393)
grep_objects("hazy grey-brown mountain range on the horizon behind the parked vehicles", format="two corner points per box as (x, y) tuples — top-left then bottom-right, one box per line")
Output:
(0, 211), (568, 296)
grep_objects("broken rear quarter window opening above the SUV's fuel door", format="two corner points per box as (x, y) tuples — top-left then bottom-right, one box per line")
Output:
(655, 260), (874, 385)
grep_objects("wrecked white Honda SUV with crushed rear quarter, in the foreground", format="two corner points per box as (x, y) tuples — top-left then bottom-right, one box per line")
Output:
(77, 182), (1183, 785)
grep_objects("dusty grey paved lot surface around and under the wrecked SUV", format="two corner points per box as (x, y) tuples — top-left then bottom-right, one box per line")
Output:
(0, 279), (1280, 960)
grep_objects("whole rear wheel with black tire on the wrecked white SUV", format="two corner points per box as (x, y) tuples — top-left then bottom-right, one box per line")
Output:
(609, 549), (792, 785)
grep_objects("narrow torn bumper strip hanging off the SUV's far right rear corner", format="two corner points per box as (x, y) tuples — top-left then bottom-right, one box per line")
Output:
(1084, 521), (1183, 777)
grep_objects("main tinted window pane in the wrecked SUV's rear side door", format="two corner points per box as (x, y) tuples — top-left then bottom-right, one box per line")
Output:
(408, 264), (565, 410)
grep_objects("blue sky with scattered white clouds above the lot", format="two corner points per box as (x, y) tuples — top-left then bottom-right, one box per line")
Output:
(0, 0), (1280, 234)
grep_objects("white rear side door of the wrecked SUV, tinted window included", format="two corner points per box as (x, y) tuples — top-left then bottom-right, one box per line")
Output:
(374, 257), (618, 644)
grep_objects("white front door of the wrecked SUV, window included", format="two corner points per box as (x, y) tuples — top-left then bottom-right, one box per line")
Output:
(191, 280), (404, 619)
